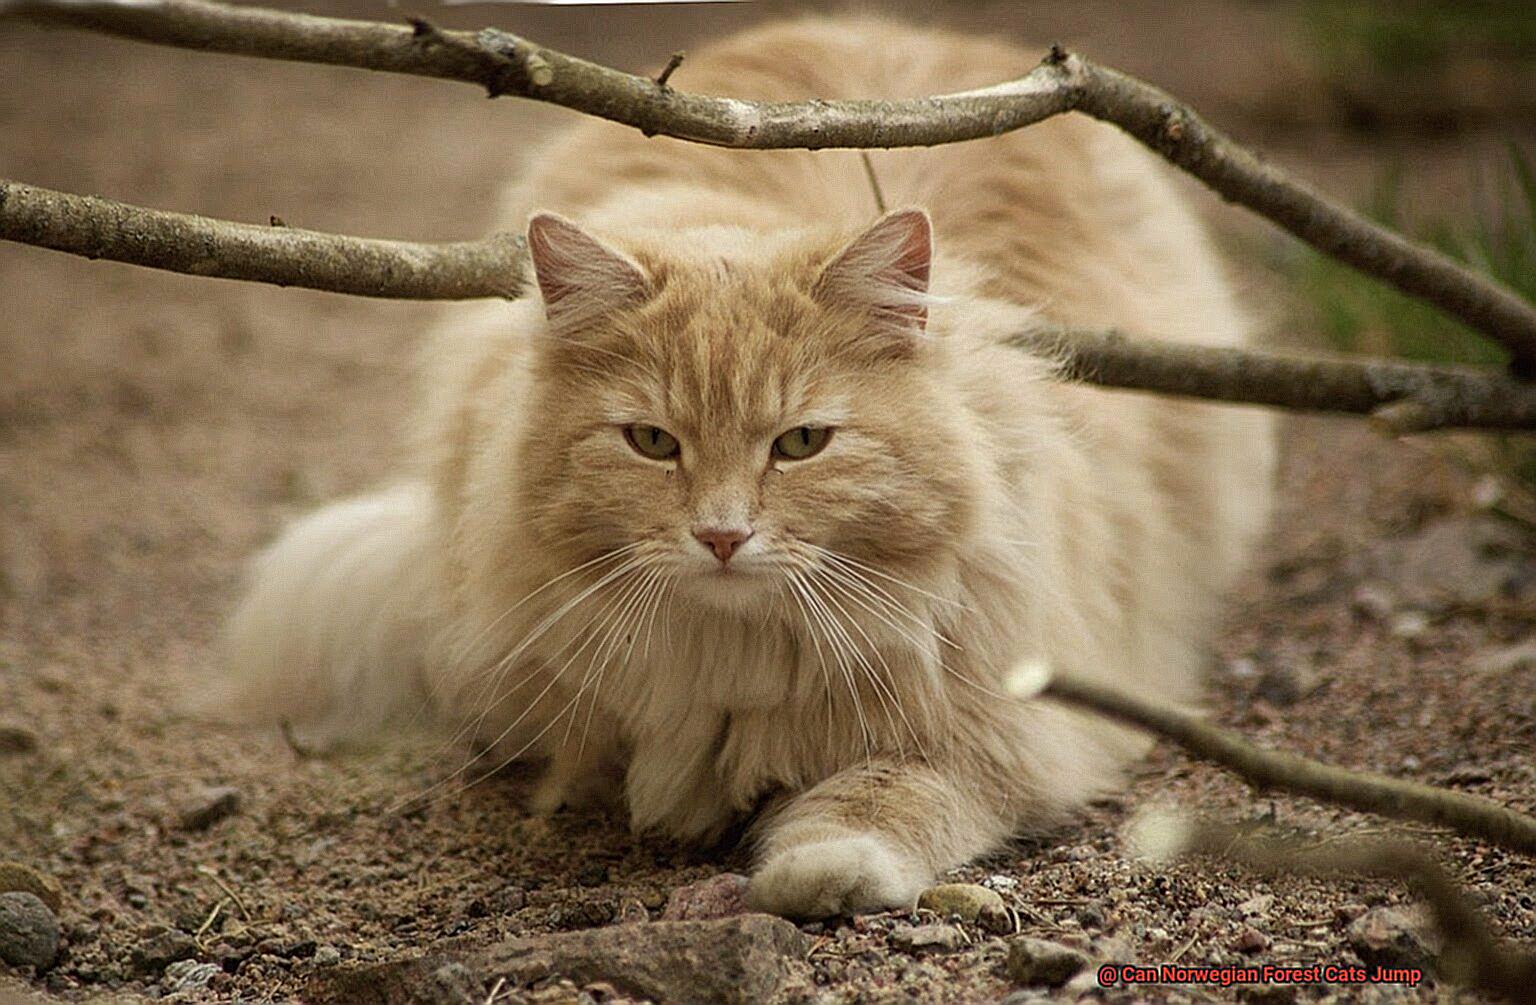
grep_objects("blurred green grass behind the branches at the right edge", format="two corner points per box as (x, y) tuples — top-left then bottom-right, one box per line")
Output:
(1293, 146), (1536, 364)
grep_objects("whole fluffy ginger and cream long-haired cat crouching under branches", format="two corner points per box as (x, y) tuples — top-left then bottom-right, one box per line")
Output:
(215, 18), (1273, 917)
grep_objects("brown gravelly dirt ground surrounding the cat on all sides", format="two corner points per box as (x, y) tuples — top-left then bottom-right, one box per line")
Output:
(0, 0), (1536, 1002)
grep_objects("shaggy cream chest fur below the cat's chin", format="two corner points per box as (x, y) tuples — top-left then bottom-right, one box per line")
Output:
(604, 605), (937, 838)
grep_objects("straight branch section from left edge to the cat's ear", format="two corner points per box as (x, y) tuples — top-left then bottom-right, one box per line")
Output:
(0, 180), (524, 300)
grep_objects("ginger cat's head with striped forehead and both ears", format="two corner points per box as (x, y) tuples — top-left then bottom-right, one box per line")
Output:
(518, 211), (974, 613)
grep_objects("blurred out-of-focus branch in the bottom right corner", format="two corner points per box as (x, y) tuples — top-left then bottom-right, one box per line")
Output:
(1155, 822), (1536, 1002)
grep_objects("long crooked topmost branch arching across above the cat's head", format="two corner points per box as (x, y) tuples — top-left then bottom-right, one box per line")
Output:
(12, 0), (1536, 376)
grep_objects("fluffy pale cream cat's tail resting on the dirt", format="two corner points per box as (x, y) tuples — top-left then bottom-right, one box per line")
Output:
(194, 484), (439, 747)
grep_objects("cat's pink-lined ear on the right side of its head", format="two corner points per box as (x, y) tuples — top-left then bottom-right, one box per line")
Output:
(814, 209), (934, 332)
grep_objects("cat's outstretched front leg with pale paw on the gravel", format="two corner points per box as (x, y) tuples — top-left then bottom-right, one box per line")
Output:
(746, 759), (1012, 917)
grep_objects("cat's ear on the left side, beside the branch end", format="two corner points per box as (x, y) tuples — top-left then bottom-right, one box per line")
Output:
(528, 214), (650, 327)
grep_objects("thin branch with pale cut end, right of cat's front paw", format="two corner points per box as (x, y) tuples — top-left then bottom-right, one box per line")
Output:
(1040, 675), (1536, 854)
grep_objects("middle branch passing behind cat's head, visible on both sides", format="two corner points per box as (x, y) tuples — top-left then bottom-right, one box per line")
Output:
(0, 178), (1536, 433)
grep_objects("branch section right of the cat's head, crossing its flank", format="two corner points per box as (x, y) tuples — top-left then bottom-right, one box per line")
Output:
(1014, 329), (1536, 433)
